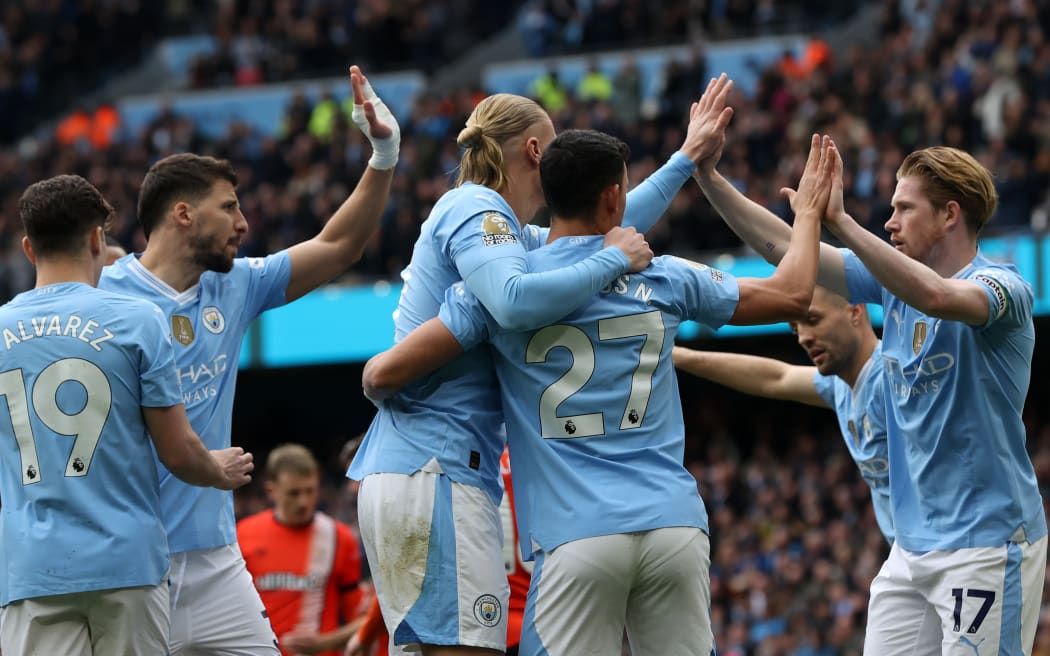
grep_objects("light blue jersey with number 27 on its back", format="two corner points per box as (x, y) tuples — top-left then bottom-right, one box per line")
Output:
(440, 236), (739, 557)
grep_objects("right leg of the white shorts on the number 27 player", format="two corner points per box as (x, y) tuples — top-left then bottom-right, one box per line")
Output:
(627, 527), (714, 656)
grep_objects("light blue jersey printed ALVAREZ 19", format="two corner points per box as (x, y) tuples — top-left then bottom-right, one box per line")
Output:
(0, 282), (182, 605)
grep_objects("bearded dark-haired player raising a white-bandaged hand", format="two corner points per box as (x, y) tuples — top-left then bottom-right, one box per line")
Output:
(101, 66), (400, 656)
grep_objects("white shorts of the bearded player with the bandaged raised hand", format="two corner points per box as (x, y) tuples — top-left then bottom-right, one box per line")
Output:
(169, 545), (279, 656)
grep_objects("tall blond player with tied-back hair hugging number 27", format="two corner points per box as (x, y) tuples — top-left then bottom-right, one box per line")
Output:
(348, 76), (732, 653)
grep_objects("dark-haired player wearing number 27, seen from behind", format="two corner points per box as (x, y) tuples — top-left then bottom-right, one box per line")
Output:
(356, 130), (831, 656)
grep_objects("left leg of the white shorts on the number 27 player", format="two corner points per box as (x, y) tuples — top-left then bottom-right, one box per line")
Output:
(519, 533), (638, 656)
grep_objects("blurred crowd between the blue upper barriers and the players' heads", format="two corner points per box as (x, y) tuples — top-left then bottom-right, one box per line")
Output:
(0, 0), (1050, 299)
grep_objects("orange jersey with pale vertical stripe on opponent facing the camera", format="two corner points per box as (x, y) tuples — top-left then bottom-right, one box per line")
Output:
(237, 510), (361, 656)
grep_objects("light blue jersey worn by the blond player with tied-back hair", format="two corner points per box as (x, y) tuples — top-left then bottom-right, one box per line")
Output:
(347, 153), (693, 502)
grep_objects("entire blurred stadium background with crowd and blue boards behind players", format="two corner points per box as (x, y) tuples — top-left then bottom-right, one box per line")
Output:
(0, 0), (1050, 656)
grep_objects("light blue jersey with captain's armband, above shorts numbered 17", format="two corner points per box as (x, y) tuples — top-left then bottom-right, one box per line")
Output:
(843, 251), (1047, 552)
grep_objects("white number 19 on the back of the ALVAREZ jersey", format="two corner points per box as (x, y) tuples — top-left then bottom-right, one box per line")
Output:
(0, 358), (113, 485)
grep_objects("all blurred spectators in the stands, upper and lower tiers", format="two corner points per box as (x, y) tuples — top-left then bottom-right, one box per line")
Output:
(0, 0), (1050, 656)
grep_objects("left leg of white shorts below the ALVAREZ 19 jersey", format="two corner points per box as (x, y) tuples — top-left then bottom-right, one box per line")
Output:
(0, 593), (91, 656)
